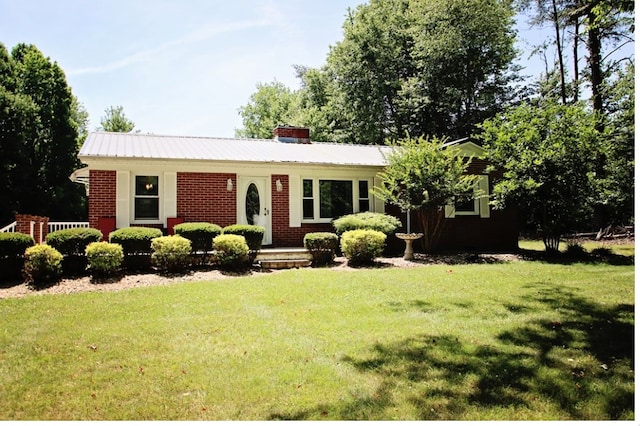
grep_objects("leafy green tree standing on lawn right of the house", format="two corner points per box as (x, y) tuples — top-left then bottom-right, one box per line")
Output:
(480, 103), (602, 252)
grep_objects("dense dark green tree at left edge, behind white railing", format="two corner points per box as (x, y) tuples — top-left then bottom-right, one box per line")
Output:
(0, 44), (86, 223)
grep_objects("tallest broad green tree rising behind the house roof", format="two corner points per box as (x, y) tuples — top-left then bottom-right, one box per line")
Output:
(325, 0), (517, 144)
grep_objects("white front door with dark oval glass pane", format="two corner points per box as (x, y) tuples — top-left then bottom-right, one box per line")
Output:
(238, 176), (271, 245)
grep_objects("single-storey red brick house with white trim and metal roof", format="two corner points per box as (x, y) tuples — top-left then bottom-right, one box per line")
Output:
(72, 126), (518, 251)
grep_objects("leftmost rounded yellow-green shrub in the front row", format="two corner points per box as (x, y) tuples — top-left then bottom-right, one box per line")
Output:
(23, 244), (62, 287)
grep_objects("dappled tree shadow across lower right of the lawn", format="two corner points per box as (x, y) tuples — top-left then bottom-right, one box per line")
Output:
(271, 284), (634, 420)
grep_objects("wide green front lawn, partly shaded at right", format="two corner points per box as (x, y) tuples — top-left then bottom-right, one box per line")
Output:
(0, 262), (634, 420)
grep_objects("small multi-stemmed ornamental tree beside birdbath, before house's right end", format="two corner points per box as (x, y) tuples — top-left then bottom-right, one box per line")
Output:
(372, 136), (478, 253)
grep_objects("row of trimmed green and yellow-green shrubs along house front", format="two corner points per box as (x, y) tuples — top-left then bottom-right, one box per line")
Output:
(0, 212), (400, 285)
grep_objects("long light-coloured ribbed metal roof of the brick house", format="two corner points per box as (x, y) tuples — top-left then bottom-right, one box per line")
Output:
(78, 132), (391, 166)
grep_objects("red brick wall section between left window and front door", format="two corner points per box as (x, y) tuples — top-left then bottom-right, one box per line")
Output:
(176, 172), (238, 227)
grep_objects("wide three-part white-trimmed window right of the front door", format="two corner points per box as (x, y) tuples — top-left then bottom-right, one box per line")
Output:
(302, 179), (371, 222)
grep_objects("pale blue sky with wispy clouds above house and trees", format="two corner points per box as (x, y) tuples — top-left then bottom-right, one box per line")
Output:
(0, 0), (632, 137)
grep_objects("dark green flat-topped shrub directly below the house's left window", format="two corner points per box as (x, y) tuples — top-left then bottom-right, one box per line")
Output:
(109, 226), (162, 270)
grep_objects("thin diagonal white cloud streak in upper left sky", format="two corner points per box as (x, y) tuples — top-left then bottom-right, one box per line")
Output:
(67, 19), (273, 75)
